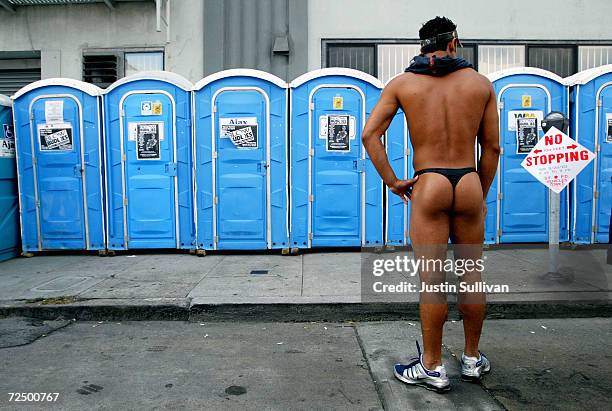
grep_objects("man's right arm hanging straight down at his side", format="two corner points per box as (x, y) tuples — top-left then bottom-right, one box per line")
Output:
(478, 83), (500, 199)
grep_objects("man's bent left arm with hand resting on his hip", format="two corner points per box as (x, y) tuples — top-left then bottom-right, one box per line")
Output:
(361, 80), (416, 201)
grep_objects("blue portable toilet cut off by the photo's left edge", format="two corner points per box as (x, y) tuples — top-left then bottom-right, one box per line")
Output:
(0, 94), (19, 261)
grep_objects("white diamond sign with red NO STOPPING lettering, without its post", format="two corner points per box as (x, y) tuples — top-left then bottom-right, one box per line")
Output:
(521, 127), (595, 193)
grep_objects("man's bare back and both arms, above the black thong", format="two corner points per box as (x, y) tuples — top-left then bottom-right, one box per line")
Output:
(362, 68), (499, 212)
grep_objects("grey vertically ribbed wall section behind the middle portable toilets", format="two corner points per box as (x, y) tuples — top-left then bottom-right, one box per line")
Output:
(204, 0), (308, 80)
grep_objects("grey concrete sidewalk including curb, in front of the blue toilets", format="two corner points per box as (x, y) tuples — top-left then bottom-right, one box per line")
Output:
(0, 248), (612, 321)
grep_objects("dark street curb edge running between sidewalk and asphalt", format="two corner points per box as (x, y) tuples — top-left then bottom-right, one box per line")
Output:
(0, 299), (612, 322)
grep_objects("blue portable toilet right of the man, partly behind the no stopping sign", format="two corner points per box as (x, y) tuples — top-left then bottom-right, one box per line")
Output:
(485, 67), (569, 243)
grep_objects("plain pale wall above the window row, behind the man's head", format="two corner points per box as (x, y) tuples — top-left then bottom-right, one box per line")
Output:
(308, 0), (612, 70)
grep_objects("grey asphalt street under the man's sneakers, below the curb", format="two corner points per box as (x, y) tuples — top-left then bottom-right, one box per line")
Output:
(0, 317), (612, 410)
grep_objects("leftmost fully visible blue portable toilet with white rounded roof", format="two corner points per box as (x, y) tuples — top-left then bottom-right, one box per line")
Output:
(13, 78), (105, 252)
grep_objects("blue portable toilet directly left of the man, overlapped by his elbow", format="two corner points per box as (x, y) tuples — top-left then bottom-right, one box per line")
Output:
(290, 68), (383, 248)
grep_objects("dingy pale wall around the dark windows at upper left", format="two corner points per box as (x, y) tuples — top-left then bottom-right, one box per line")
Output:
(0, 0), (204, 81)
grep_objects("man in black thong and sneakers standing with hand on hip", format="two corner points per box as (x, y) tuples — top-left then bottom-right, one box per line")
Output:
(362, 17), (500, 392)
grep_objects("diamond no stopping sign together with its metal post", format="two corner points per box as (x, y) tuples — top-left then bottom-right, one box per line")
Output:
(521, 111), (595, 280)
